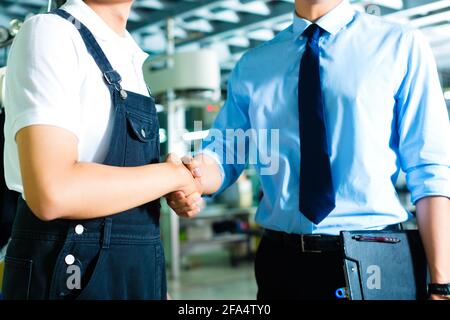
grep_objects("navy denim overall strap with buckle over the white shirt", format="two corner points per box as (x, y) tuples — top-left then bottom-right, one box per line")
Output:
(50, 9), (127, 99)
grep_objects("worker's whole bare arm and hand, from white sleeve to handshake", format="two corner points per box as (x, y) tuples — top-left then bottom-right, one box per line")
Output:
(16, 126), (198, 220)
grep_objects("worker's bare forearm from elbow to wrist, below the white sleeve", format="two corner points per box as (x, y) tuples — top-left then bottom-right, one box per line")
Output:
(25, 162), (185, 220)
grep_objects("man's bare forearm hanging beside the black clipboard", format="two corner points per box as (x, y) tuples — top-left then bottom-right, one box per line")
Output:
(416, 197), (450, 283)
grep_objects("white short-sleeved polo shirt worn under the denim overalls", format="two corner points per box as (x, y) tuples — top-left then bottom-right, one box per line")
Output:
(4, 0), (148, 193)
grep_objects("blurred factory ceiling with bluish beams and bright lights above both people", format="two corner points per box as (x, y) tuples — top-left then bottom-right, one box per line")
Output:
(0, 0), (450, 85)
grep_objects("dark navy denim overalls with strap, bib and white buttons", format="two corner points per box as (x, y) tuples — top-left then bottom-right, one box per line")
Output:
(2, 10), (166, 299)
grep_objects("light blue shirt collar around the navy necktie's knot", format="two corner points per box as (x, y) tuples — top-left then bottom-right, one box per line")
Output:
(292, 0), (355, 39)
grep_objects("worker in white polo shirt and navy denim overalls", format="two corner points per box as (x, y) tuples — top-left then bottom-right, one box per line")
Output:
(3, 0), (199, 299)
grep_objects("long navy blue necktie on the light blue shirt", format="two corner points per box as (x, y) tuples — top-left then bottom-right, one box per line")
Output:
(298, 24), (335, 224)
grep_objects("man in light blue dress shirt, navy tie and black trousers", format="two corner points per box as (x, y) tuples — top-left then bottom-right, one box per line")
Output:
(168, 0), (450, 299)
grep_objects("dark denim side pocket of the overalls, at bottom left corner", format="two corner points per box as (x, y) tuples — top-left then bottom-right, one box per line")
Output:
(2, 256), (33, 300)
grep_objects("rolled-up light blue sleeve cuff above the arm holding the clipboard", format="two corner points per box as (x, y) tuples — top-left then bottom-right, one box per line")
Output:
(406, 165), (450, 204)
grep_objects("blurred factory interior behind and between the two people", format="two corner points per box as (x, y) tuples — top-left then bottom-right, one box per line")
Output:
(0, 0), (450, 299)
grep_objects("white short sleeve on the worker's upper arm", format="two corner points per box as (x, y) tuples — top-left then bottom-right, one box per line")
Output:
(5, 14), (83, 137)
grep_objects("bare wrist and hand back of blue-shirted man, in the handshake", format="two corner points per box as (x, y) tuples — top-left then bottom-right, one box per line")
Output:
(195, 153), (222, 194)
